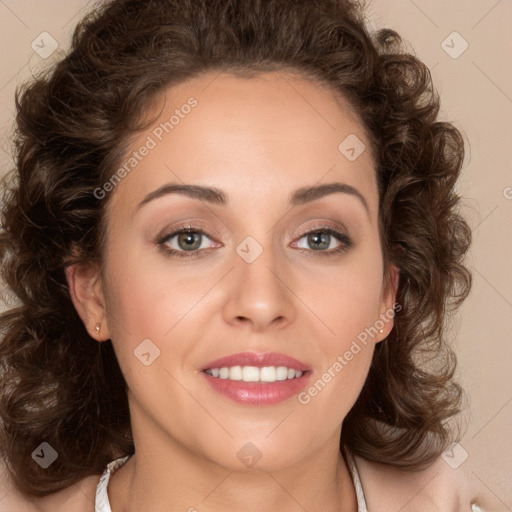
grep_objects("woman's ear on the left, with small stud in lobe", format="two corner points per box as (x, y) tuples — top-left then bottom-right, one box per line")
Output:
(65, 263), (110, 341)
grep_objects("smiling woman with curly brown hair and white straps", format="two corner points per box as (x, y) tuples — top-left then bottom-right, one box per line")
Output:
(0, 0), (492, 512)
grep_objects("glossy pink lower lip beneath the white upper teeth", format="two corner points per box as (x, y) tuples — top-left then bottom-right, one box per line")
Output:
(202, 372), (309, 405)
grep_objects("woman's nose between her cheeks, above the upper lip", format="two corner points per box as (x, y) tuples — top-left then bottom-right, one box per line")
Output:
(223, 243), (296, 332)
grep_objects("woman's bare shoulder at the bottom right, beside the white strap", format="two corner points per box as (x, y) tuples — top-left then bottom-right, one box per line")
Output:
(356, 457), (503, 512)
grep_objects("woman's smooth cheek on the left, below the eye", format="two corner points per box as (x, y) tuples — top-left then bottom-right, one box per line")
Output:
(101, 251), (227, 400)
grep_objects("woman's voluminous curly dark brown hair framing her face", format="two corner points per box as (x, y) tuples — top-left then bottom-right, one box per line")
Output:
(0, 0), (471, 496)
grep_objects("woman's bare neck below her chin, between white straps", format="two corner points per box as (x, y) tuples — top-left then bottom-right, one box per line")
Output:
(108, 412), (357, 512)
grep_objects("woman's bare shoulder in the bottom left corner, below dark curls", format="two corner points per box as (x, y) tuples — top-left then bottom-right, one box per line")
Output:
(0, 467), (100, 512)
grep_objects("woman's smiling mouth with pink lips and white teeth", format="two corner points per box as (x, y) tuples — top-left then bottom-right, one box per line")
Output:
(201, 352), (311, 406)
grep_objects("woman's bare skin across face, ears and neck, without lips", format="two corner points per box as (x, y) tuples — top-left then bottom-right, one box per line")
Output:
(67, 72), (398, 512)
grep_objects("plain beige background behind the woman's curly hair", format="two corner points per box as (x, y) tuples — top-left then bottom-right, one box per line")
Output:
(0, 0), (512, 510)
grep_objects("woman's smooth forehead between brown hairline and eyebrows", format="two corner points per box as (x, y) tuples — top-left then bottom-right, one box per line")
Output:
(108, 72), (376, 216)
